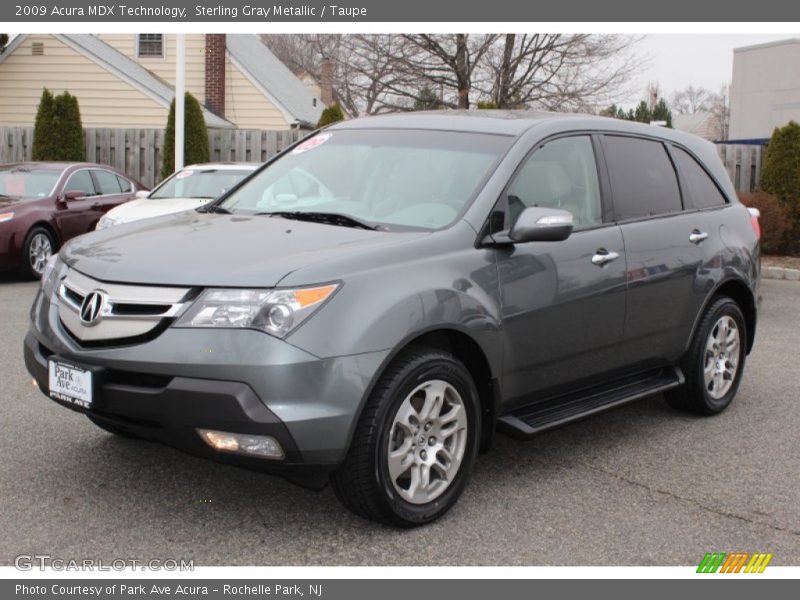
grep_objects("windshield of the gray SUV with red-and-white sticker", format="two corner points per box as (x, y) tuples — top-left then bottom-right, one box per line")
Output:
(217, 129), (512, 230)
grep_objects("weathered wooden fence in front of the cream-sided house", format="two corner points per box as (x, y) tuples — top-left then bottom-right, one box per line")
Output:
(0, 127), (308, 187)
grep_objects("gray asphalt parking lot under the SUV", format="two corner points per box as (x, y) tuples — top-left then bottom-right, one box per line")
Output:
(0, 276), (800, 565)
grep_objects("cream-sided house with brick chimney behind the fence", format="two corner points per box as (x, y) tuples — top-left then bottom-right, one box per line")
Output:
(0, 33), (324, 130)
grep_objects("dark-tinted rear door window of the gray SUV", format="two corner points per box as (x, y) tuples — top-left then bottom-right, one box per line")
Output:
(603, 135), (683, 221)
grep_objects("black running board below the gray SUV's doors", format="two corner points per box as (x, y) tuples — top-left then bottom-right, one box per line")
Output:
(497, 367), (684, 438)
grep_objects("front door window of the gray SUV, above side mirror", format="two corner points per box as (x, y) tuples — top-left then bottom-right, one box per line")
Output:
(508, 135), (603, 228)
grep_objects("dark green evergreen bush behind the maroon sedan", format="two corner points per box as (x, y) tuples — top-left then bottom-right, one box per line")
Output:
(32, 88), (86, 162)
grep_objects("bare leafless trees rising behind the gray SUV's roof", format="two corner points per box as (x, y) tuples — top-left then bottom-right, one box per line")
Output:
(262, 33), (642, 116)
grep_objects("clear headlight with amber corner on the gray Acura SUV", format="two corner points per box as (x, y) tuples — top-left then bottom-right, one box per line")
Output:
(175, 283), (339, 337)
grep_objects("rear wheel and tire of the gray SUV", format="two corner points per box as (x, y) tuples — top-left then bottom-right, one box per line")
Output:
(665, 296), (747, 415)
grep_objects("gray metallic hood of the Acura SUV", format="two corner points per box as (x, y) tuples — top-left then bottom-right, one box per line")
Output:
(61, 211), (428, 287)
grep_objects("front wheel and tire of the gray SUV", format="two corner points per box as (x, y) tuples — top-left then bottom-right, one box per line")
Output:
(331, 348), (481, 527)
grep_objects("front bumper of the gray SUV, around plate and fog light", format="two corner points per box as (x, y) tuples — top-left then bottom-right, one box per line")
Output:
(29, 294), (388, 470)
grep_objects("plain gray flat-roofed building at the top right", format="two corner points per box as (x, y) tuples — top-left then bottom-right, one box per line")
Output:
(729, 38), (800, 143)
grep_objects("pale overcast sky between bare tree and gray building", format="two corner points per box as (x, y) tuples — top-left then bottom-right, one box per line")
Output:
(629, 32), (800, 104)
